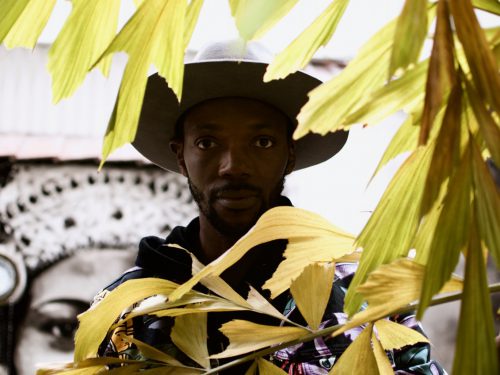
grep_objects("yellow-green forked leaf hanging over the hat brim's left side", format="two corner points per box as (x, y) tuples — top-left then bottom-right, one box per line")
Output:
(101, 0), (187, 167)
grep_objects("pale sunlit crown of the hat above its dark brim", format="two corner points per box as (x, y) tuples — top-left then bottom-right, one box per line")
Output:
(192, 39), (274, 64)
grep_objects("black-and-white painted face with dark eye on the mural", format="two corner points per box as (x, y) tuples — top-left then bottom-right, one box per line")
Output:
(14, 249), (135, 375)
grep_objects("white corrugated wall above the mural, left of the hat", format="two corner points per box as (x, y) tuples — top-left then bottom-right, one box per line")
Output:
(0, 45), (126, 138)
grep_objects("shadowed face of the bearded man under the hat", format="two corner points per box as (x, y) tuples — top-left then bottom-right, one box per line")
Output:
(172, 98), (294, 237)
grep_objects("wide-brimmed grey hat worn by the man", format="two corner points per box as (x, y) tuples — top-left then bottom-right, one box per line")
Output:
(132, 41), (348, 172)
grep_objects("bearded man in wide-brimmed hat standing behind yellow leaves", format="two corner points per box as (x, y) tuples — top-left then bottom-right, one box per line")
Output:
(97, 42), (443, 374)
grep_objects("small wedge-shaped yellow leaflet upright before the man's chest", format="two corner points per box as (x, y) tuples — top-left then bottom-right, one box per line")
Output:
(290, 263), (335, 330)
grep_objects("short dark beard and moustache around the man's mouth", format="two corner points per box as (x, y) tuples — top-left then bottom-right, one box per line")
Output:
(188, 176), (285, 239)
